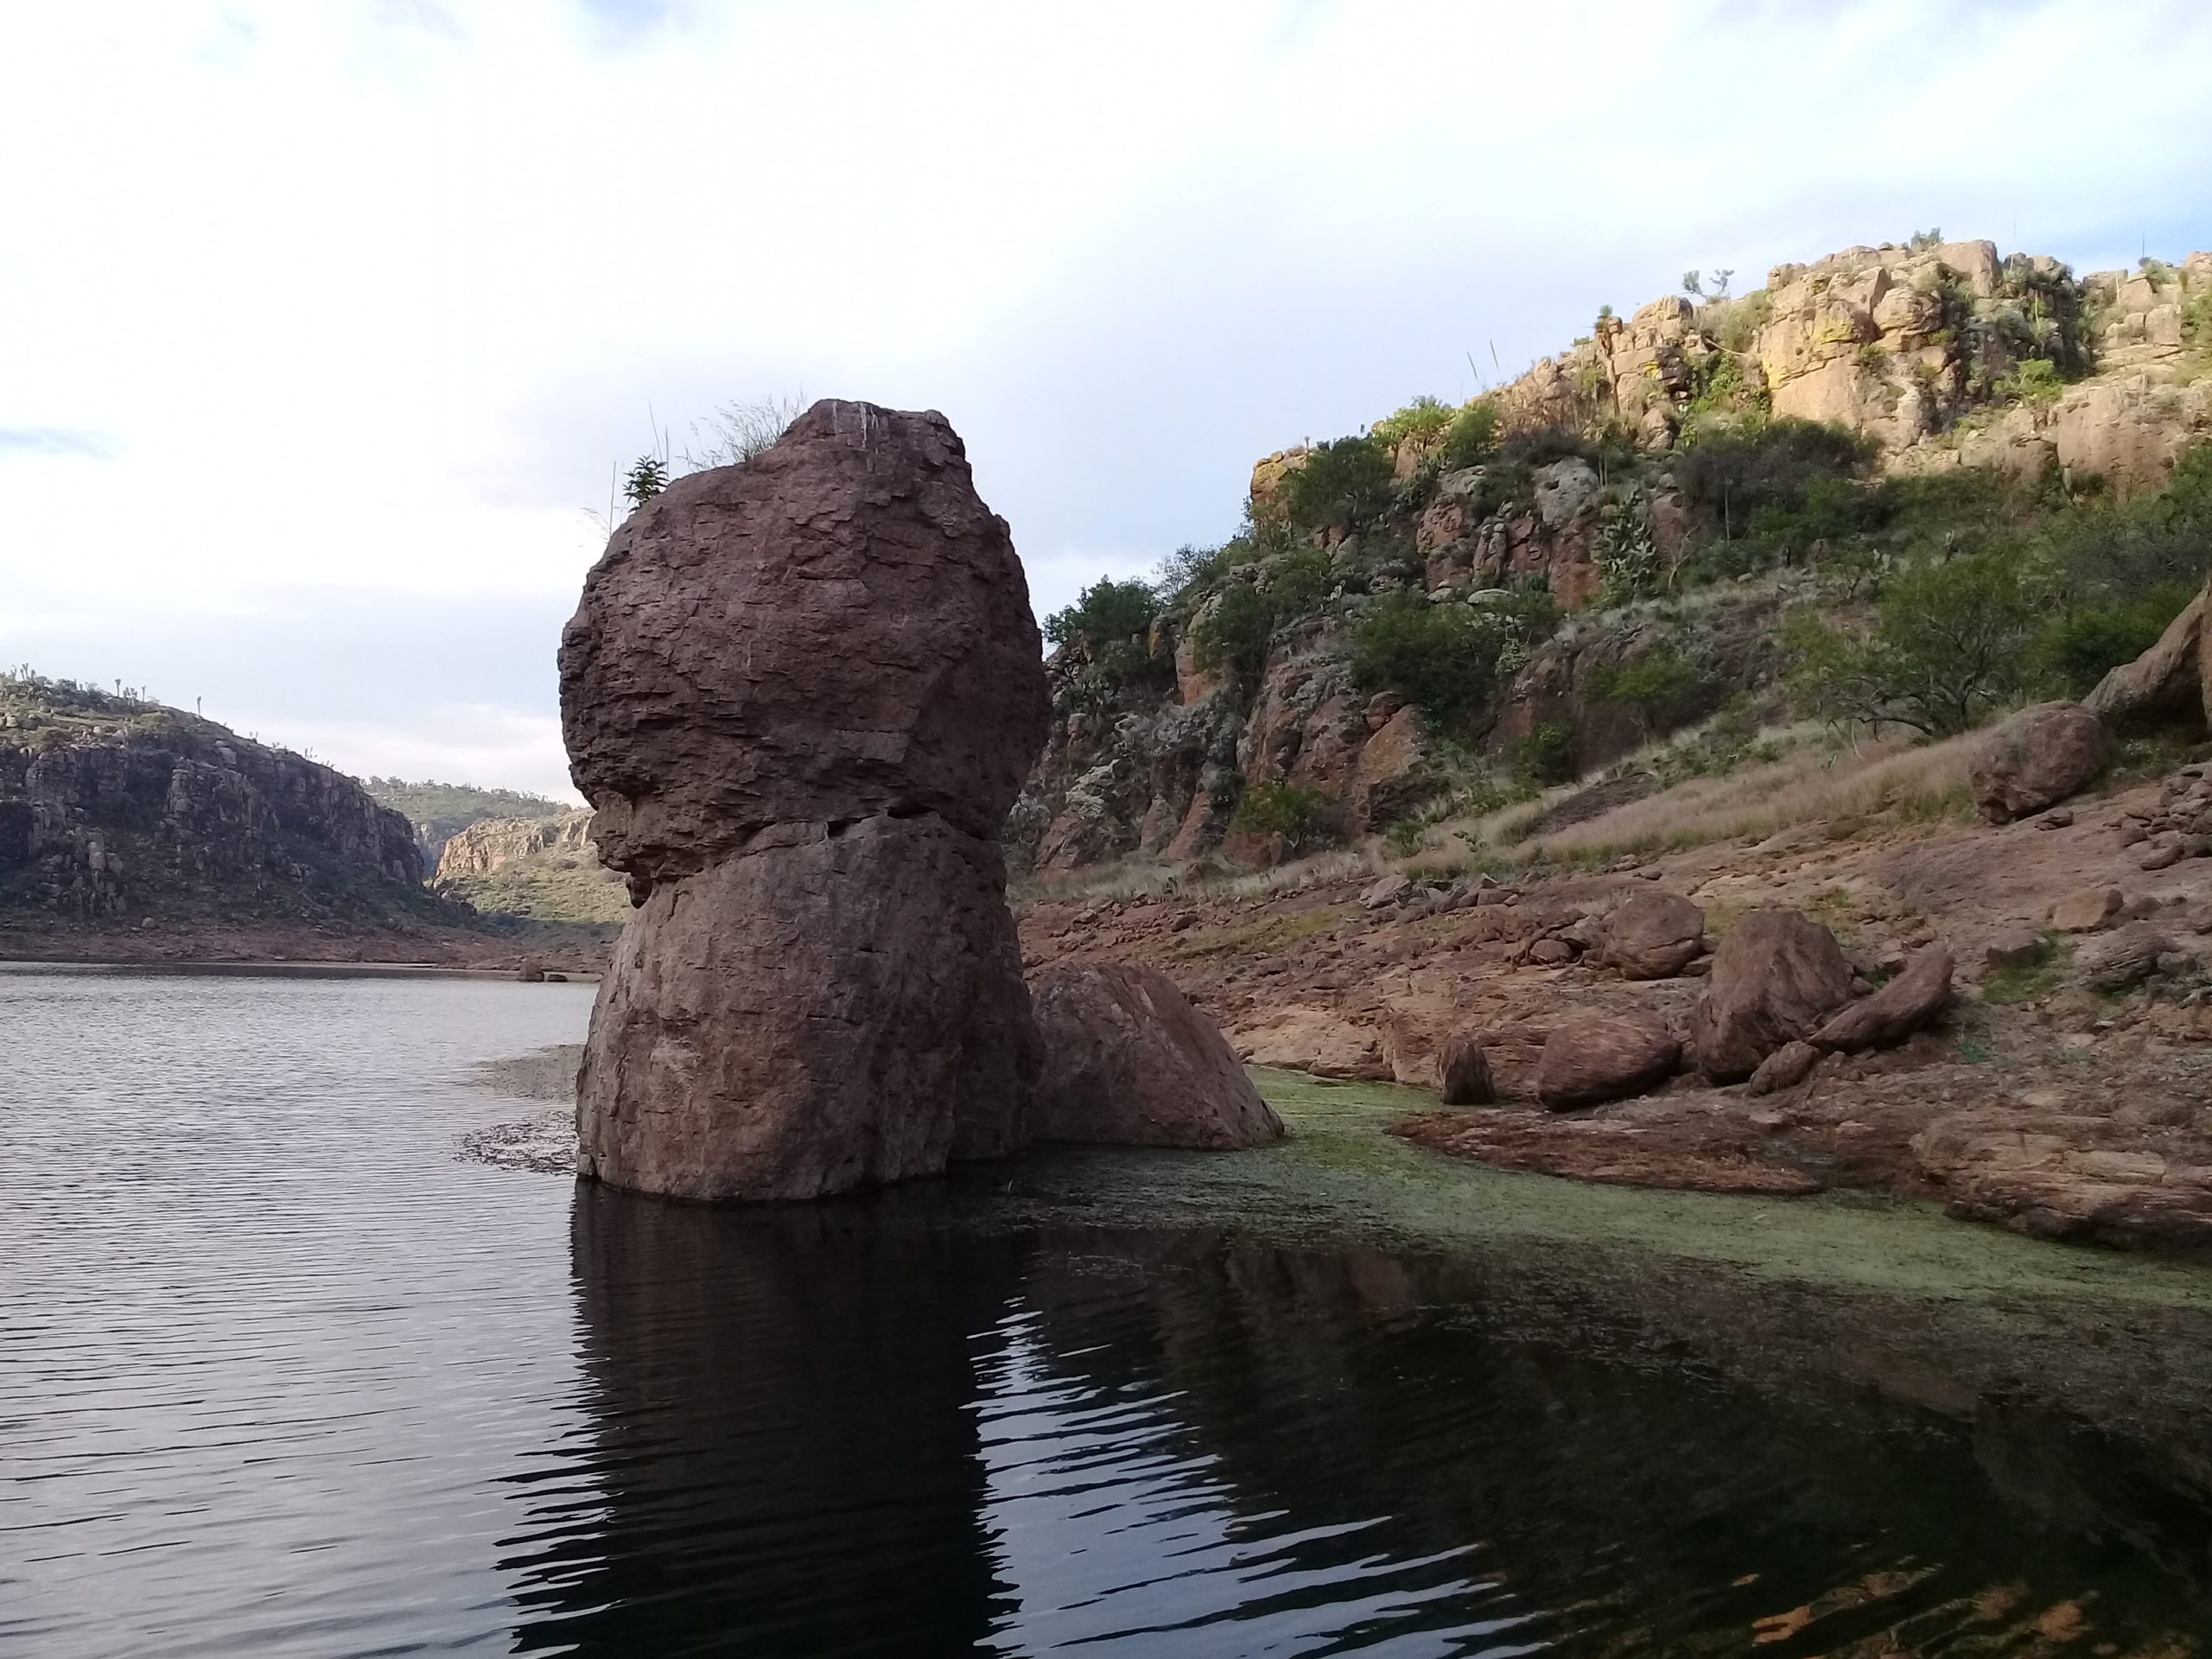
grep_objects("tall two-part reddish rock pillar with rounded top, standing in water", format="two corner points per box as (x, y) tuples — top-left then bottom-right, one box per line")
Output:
(560, 400), (1048, 1199)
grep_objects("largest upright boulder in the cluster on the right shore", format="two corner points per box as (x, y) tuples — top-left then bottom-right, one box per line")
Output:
(1692, 909), (1852, 1084)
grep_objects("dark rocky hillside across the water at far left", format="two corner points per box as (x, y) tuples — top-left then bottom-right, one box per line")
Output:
(0, 672), (462, 938)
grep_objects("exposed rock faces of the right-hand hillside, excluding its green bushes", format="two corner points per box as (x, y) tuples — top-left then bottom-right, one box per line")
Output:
(1008, 238), (2212, 876)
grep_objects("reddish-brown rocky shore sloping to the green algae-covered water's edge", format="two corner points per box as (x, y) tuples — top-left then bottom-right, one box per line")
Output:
(1020, 766), (2212, 1256)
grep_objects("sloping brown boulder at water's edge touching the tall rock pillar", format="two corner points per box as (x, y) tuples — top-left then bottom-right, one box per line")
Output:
(1028, 963), (1283, 1148)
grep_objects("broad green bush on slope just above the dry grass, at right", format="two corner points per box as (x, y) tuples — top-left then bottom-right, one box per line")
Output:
(1783, 553), (2042, 736)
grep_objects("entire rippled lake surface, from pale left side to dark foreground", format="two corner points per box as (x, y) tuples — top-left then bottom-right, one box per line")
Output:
(0, 969), (2212, 1659)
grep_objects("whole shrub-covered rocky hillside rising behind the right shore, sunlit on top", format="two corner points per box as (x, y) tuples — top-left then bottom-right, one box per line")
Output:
(1008, 232), (2212, 878)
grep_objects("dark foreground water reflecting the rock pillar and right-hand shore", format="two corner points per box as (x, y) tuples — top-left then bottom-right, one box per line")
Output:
(509, 1190), (2212, 1659)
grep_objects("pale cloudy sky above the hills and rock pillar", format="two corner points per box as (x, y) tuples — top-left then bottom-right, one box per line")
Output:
(0, 0), (2212, 797)
